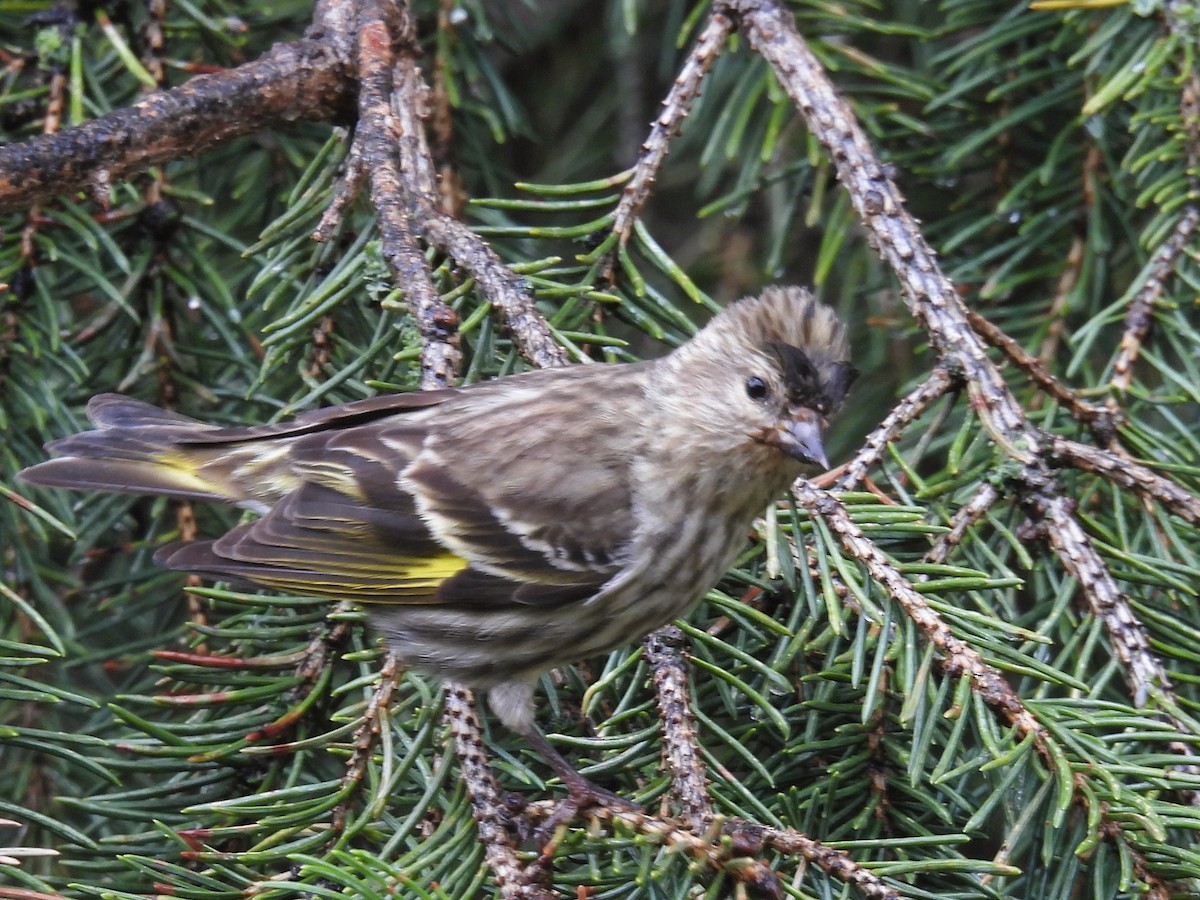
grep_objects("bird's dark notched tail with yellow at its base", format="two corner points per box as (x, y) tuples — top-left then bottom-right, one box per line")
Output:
(18, 394), (245, 503)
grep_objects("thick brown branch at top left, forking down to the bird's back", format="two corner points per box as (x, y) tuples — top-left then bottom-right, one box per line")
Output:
(0, 0), (569, 376)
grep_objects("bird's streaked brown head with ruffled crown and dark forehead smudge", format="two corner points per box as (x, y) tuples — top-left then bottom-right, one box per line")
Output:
(666, 287), (858, 468)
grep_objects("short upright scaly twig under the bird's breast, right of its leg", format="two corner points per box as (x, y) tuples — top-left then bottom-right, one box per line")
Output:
(644, 625), (713, 832)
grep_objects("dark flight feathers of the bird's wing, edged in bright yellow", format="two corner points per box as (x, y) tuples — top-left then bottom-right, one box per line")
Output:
(157, 433), (614, 607)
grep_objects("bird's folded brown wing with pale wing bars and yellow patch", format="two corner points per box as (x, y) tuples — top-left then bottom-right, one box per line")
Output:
(160, 370), (648, 606)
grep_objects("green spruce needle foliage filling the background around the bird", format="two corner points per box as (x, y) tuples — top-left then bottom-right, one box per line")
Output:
(0, 0), (1200, 900)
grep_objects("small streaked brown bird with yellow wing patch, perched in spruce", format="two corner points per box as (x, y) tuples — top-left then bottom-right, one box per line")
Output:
(22, 287), (856, 797)
